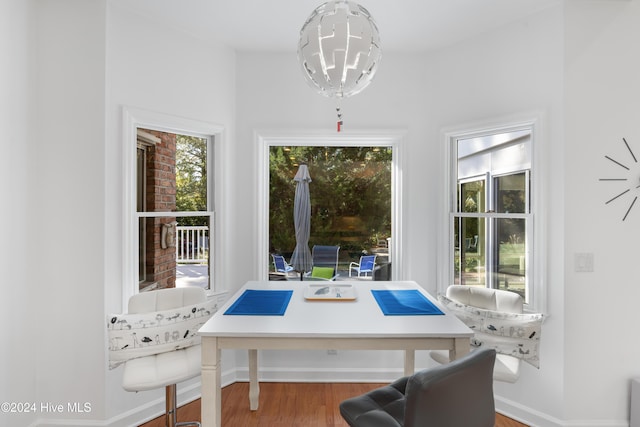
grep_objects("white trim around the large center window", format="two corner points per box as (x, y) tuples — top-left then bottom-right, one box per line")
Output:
(254, 130), (405, 280)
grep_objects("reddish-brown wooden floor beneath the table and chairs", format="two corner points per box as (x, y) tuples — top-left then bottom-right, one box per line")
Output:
(140, 383), (527, 427)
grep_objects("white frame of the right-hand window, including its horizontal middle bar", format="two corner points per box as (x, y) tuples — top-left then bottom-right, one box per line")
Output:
(438, 113), (548, 312)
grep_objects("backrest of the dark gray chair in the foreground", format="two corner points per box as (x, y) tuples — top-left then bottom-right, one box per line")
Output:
(404, 349), (496, 427)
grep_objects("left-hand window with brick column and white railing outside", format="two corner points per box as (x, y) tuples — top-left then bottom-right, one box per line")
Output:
(123, 109), (222, 304)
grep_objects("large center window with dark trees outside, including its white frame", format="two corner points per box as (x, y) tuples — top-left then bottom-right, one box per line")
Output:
(255, 133), (402, 280)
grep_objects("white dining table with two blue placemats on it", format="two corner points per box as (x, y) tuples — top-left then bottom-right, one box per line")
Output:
(199, 281), (473, 427)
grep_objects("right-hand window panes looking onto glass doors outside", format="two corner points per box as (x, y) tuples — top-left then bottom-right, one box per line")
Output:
(447, 124), (542, 306)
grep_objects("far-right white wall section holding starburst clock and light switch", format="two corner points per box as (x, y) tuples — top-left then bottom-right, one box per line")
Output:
(563, 0), (640, 426)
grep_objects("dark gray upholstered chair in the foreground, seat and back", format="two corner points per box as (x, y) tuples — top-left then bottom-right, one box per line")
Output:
(340, 349), (496, 427)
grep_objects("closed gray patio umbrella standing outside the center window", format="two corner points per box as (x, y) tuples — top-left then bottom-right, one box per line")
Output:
(291, 165), (312, 280)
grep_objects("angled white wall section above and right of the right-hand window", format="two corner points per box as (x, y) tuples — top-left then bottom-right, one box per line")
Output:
(431, 7), (564, 426)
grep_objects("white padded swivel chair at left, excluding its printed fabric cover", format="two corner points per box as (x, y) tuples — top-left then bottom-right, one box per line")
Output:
(122, 287), (206, 427)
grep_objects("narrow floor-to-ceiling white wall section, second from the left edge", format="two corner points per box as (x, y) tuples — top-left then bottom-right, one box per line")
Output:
(28, 0), (105, 419)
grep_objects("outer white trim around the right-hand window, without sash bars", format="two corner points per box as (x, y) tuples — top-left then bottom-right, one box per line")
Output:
(437, 113), (549, 313)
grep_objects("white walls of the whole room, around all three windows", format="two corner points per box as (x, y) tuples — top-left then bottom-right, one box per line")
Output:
(5, 0), (640, 427)
